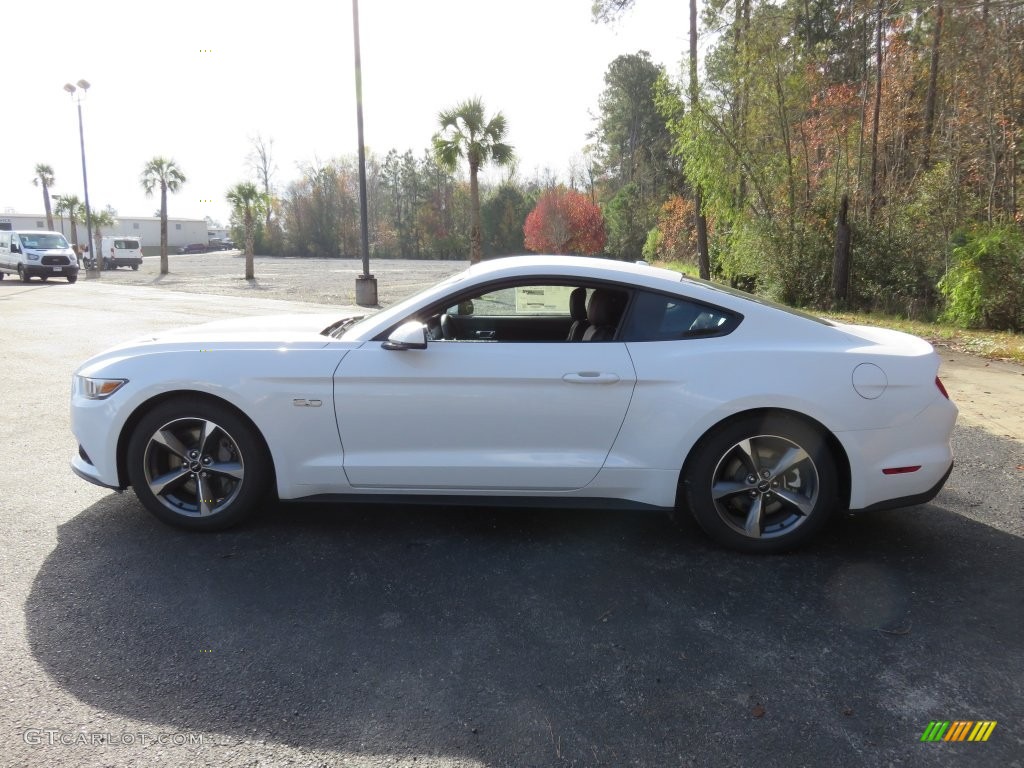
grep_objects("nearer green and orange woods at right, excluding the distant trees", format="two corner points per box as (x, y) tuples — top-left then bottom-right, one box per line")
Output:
(594, 0), (1024, 331)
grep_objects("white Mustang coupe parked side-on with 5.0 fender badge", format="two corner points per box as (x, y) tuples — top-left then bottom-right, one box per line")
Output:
(72, 257), (956, 552)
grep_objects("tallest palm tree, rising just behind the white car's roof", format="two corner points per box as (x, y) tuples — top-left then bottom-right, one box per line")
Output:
(433, 98), (515, 264)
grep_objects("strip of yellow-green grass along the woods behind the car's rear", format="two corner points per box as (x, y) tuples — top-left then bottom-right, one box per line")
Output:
(655, 261), (1024, 365)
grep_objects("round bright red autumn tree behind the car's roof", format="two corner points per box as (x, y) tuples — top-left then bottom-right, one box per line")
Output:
(522, 186), (607, 256)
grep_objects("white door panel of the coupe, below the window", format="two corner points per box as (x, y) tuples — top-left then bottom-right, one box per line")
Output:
(335, 331), (636, 493)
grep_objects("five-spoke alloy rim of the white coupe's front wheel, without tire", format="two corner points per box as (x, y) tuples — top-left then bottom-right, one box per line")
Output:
(142, 418), (245, 517)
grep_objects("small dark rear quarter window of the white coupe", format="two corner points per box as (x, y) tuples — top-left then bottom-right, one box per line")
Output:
(622, 291), (742, 341)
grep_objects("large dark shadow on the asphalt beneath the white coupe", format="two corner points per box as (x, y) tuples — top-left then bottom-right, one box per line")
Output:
(26, 442), (1024, 766)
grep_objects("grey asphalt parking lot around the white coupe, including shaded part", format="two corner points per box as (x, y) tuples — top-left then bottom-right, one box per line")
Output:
(0, 262), (1024, 768)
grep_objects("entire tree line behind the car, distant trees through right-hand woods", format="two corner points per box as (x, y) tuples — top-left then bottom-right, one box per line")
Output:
(29, 0), (1024, 330)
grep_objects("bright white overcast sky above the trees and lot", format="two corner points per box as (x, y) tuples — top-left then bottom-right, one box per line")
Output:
(0, 0), (688, 228)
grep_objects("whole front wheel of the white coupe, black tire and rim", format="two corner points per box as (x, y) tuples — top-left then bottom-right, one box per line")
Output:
(126, 397), (273, 530)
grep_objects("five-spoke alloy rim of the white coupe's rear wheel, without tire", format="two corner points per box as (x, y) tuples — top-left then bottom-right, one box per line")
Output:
(711, 435), (820, 539)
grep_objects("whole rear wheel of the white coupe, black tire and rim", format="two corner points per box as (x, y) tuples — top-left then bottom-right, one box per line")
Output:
(680, 414), (839, 554)
